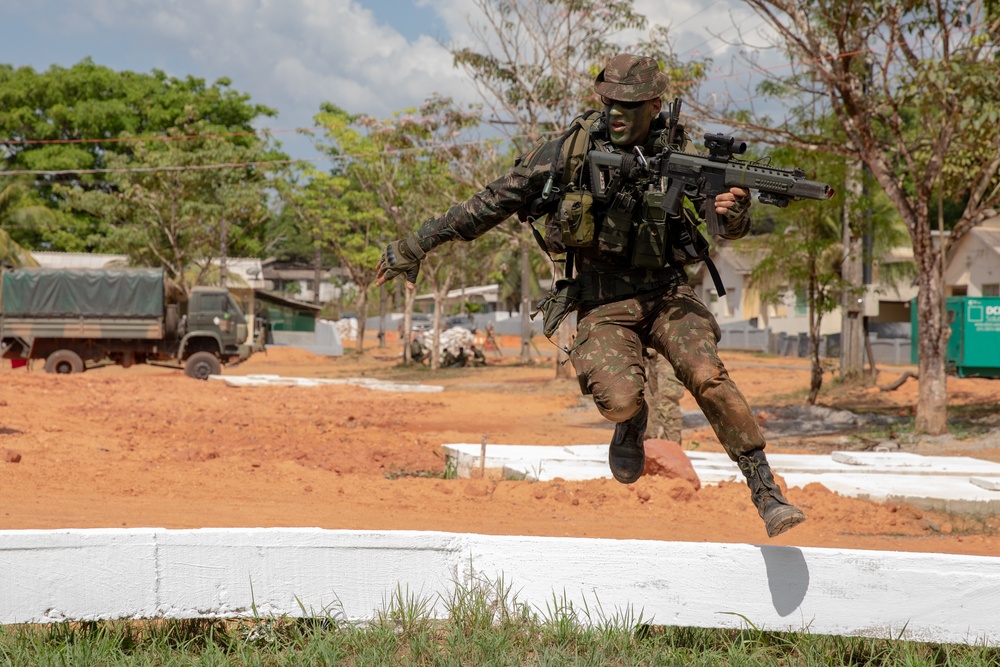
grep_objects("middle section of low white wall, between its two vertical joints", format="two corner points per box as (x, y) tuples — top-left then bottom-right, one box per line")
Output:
(157, 528), (458, 620)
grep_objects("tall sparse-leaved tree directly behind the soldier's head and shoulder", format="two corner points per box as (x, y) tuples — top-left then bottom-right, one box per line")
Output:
(452, 0), (704, 370)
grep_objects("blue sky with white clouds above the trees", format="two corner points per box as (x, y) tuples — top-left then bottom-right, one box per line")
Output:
(0, 0), (772, 166)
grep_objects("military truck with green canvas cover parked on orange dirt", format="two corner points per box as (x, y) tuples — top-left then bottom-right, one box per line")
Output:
(0, 268), (251, 380)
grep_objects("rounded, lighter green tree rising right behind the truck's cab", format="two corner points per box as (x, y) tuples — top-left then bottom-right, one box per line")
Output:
(65, 122), (273, 290)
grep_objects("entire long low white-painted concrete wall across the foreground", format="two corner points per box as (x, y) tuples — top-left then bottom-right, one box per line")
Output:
(0, 528), (1000, 645)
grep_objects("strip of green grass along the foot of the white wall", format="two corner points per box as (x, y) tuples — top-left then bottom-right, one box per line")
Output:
(0, 579), (1000, 667)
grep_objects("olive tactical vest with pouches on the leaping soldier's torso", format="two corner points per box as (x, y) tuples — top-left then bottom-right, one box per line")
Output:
(520, 111), (726, 298)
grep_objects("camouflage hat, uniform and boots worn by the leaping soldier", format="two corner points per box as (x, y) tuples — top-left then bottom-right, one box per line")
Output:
(379, 54), (804, 535)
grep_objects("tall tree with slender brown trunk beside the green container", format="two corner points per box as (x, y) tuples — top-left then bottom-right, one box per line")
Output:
(704, 0), (1000, 434)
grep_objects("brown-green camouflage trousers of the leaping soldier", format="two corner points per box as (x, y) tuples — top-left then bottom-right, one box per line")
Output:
(570, 285), (764, 461)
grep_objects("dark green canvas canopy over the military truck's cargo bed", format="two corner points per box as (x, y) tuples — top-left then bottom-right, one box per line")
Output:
(0, 269), (163, 319)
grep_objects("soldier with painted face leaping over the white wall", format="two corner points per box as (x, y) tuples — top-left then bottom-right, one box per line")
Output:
(376, 54), (805, 537)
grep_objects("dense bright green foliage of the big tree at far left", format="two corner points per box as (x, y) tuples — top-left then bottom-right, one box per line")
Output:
(0, 58), (275, 256)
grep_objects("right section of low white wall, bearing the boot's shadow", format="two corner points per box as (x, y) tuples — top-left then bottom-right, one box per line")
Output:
(462, 536), (1000, 644)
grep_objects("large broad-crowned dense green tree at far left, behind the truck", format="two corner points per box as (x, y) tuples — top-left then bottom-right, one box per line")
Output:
(0, 58), (276, 250)
